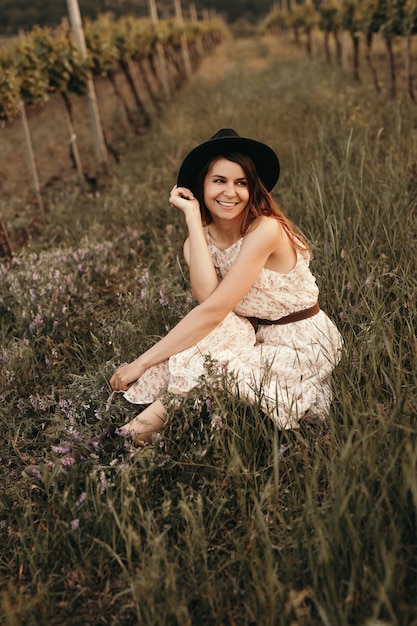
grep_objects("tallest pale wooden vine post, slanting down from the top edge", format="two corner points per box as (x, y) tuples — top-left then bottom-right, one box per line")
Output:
(67, 0), (109, 174)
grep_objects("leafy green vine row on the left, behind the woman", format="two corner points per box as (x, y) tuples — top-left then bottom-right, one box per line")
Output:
(0, 15), (225, 122)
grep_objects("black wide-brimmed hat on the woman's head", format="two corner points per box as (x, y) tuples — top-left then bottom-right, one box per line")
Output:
(177, 128), (279, 191)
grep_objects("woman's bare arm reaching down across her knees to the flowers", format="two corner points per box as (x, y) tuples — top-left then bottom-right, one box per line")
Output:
(110, 217), (282, 390)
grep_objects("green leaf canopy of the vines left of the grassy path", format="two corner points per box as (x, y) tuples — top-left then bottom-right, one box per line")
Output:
(0, 15), (226, 120)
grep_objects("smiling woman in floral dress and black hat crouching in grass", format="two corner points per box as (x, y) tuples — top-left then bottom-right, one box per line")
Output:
(110, 129), (342, 445)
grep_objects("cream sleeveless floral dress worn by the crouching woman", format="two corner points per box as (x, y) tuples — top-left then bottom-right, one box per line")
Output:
(124, 230), (342, 429)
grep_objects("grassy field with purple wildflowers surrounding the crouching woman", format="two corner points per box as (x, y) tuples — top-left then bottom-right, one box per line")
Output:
(0, 37), (417, 626)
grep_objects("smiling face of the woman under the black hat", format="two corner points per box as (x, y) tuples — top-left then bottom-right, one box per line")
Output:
(204, 157), (249, 220)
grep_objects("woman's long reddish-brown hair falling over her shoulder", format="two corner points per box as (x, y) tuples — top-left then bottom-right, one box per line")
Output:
(195, 152), (310, 250)
